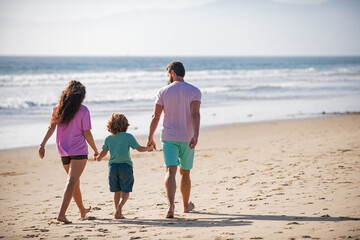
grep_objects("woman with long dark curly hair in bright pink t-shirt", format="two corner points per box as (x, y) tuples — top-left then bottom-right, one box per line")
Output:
(39, 80), (99, 223)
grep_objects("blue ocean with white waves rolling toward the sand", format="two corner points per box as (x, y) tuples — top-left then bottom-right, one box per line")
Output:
(0, 57), (360, 149)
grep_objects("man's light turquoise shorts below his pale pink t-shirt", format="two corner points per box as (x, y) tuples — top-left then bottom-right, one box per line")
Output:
(162, 141), (195, 170)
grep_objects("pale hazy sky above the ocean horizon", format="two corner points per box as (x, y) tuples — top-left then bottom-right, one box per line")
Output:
(0, 0), (360, 56)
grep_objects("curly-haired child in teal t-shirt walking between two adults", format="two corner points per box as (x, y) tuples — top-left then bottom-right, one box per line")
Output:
(96, 113), (154, 219)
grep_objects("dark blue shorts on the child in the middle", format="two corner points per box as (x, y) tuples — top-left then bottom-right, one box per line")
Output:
(109, 163), (134, 192)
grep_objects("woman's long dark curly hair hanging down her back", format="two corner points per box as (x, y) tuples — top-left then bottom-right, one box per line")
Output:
(51, 80), (86, 125)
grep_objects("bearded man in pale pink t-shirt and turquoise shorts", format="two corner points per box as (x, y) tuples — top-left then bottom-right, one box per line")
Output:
(148, 61), (201, 218)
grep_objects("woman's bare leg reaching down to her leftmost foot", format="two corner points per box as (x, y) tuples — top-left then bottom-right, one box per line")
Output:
(57, 159), (87, 223)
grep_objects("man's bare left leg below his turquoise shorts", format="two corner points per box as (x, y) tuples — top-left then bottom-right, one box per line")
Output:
(165, 165), (177, 218)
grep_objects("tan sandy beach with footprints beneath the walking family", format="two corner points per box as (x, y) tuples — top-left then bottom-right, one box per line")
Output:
(0, 115), (360, 239)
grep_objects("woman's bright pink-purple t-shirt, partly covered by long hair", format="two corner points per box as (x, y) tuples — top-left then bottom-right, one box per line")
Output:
(53, 105), (91, 157)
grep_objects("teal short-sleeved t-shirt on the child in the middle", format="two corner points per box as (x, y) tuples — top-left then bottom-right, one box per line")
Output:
(102, 132), (140, 166)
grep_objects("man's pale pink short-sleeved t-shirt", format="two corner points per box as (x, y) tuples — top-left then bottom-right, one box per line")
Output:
(155, 82), (201, 142)
